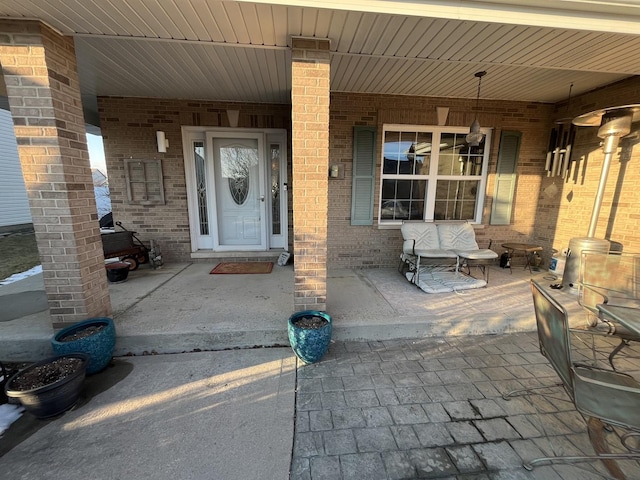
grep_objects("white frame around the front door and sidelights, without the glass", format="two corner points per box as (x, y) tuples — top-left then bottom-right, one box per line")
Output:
(182, 126), (288, 257)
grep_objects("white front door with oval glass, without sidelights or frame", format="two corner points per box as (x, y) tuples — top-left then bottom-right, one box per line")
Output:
(211, 136), (266, 250)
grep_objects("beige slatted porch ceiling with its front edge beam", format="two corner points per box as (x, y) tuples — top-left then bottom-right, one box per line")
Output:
(0, 0), (640, 115)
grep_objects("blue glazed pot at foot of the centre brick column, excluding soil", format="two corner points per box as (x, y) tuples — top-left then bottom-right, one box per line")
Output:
(288, 310), (332, 363)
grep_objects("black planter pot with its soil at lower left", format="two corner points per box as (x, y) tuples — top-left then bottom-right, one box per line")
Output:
(5, 353), (89, 418)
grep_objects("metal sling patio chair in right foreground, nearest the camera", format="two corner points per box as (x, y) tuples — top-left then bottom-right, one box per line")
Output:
(523, 281), (640, 478)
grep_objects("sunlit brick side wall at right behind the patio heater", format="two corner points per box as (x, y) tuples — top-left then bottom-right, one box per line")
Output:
(535, 77), (640, 260)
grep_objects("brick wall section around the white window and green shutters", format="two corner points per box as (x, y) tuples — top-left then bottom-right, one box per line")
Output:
(329, 93), (553, 267)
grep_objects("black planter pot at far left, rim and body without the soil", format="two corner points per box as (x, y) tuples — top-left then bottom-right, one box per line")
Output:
(5, 353), (89, 418)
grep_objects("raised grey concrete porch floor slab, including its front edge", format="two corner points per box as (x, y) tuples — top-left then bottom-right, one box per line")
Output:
(0, 262), (544, 361)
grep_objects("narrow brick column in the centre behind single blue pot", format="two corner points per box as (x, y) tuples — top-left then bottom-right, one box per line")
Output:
(291, 37), (330, 311)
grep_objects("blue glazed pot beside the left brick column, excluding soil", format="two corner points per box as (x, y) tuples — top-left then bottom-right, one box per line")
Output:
(51, 317), (116, 375)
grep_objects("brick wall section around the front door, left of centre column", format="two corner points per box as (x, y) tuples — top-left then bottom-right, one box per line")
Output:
(98, 97), (292, 262)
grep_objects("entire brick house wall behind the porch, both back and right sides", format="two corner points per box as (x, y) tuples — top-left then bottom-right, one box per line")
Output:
(99, 78), (640, 268)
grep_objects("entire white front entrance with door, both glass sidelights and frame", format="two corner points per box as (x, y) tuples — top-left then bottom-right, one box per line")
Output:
(183, 127), (288, 254)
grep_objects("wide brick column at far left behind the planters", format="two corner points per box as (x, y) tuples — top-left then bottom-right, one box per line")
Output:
(0, 20), (111, 328)
